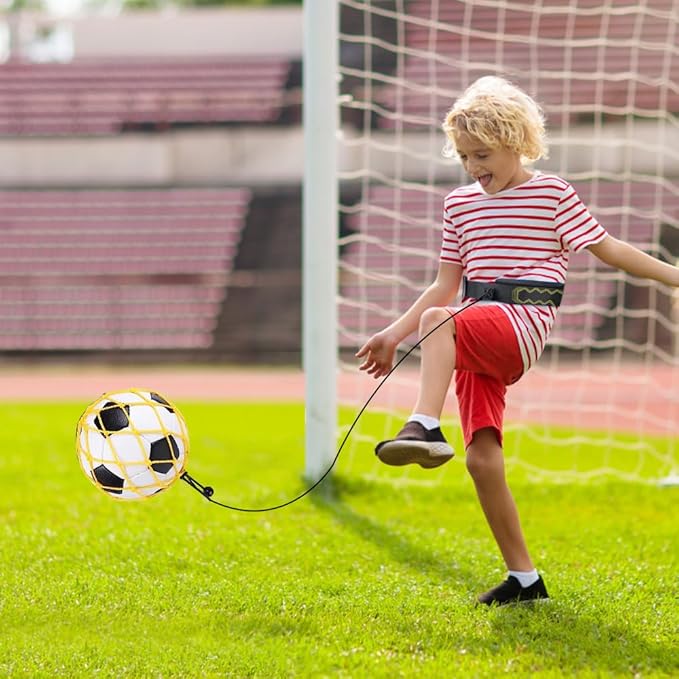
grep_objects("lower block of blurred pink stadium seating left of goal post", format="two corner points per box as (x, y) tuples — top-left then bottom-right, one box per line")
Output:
(0, 189), (250, 351)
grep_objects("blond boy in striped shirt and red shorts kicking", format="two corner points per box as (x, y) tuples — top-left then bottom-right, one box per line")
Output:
(356, 77), (679, 605)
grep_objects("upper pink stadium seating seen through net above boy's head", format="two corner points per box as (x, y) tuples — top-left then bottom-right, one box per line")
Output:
(375, 0), (679, 128)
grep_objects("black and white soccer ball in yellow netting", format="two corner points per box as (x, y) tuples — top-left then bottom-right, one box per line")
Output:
(76, 389), (189, 500)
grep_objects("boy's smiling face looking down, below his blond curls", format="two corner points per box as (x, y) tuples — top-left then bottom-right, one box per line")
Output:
(455, 132), (532, 195)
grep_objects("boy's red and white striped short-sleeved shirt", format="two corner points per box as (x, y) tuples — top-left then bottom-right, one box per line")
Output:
(441, 172), (607, 371)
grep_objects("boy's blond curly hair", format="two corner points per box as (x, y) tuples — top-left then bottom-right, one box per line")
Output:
(442, 76), (548, 163)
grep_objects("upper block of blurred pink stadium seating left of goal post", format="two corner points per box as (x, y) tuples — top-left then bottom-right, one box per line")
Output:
(0, 57), (290, 135)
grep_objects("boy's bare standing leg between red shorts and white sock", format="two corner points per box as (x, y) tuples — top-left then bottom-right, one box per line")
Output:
(468, 428), (533, 572)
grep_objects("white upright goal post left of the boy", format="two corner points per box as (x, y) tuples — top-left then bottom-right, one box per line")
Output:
(302, 0), (339, 481)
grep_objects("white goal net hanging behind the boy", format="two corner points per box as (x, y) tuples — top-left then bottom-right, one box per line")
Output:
(339, 0), (679, 481)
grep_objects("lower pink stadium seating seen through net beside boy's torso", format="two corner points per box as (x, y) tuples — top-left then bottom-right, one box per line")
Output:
(339, 181), (679, 348)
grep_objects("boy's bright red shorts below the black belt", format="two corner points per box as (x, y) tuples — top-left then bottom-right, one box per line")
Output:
(455, 304), (523, 448)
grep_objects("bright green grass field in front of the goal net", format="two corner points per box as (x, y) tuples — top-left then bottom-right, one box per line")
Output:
(0, 403), (679, 678)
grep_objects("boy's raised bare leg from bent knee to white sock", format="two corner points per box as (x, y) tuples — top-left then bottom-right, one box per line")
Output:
(413, 307), (455, 419)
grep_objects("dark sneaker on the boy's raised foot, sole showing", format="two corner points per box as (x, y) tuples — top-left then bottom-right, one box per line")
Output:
(375, 422), (455, 469)
